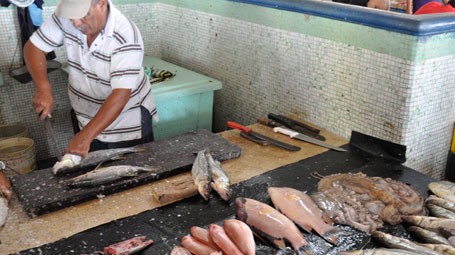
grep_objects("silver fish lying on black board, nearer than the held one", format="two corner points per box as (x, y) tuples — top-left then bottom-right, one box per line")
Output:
(65, 165), (159, 188)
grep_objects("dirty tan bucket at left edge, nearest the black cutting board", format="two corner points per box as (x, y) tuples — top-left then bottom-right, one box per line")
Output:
(0, 137), (36, 174)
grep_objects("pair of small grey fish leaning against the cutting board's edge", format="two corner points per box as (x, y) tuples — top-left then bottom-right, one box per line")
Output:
(191, 149), (232, 201)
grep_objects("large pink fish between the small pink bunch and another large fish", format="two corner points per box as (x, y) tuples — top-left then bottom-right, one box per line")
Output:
(235, 197), (313, 254)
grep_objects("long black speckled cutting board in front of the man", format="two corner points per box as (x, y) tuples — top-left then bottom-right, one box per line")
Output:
(11, 129), (241, 217)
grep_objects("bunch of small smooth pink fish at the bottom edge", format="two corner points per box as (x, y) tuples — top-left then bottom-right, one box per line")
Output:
(171, 219), (256, 255)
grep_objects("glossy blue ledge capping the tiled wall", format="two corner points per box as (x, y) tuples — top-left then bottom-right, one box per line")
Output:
(227, 0), (455, 36)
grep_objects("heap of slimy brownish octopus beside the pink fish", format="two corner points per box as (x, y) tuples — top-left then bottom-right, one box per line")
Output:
(311, 173), (426, 233)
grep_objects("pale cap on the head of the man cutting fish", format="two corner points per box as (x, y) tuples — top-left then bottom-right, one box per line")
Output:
(55, 0), (92, 19)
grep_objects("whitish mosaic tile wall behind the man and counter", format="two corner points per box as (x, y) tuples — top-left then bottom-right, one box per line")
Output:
(0, 1), (455, 178)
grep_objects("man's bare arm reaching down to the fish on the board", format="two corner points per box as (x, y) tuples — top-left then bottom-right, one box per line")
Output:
(65, 89), (131, 157)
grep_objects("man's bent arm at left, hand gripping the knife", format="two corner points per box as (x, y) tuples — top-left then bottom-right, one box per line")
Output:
(24, 40), (54, 120)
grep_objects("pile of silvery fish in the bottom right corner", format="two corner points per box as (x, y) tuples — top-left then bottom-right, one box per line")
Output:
(341, 181), (455, 255)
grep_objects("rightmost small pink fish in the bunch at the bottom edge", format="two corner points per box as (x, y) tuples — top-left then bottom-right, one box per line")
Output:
(223, 219), (256, 255)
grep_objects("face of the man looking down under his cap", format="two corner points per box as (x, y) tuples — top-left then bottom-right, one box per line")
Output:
(71, 0), (105, 36)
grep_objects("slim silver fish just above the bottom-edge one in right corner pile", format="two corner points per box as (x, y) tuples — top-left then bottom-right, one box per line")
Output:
(371, 231), (441, 255)
